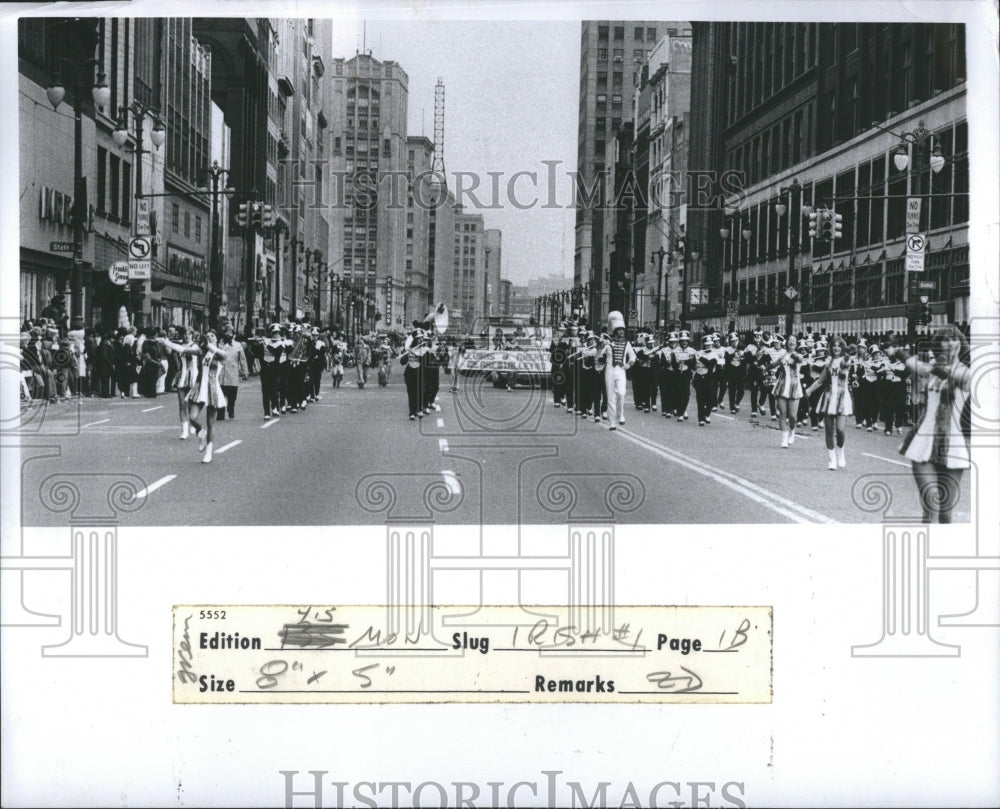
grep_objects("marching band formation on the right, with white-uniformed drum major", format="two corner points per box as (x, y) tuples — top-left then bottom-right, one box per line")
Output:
(549, 312), (944, 470)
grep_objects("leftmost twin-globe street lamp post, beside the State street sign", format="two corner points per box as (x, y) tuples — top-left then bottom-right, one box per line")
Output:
(45, 57), (111, 324)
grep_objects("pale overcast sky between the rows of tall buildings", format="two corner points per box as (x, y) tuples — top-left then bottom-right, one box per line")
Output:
(333, 20), (580, 284)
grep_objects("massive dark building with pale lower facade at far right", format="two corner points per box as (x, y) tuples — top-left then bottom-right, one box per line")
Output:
(688, 23), (969, 332)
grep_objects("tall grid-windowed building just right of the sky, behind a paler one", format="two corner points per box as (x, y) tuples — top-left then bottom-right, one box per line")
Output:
(573, 20), (690, 320)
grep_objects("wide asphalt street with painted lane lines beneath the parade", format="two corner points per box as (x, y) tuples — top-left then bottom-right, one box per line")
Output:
(22, 375), (970, 526)
